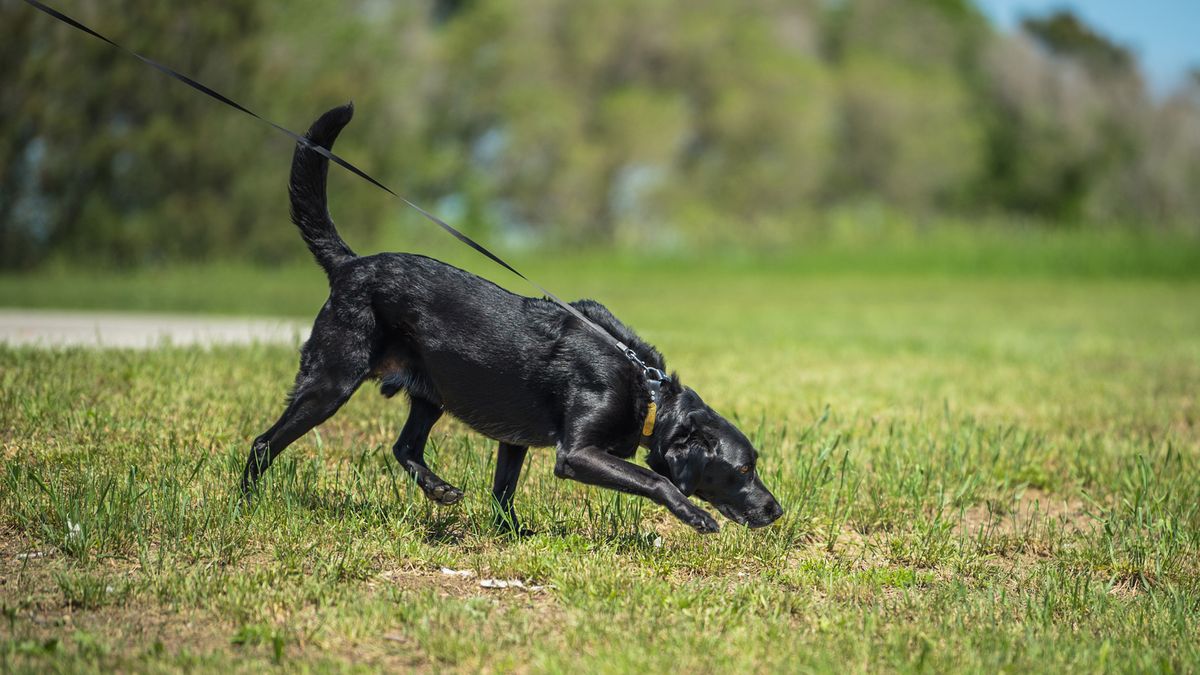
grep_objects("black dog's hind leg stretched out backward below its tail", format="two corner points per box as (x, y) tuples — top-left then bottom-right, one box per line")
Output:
(241, 305), (373, 496)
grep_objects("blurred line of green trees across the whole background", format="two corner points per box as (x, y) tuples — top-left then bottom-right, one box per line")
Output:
(0, 0), (1200, 268)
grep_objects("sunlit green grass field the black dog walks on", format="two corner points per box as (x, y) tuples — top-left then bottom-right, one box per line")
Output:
(0, 243), (1200, 673)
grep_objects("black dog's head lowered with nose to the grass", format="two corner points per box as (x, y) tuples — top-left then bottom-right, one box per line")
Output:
(647, 381), (784, 527)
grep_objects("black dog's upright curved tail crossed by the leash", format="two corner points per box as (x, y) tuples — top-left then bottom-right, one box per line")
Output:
(288, 103), (355, 276)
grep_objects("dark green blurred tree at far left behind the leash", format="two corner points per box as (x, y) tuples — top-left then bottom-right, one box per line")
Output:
(0, 0), (258, 267)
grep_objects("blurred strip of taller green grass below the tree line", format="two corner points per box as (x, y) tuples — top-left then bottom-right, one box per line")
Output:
(0, 217), (1200, 317)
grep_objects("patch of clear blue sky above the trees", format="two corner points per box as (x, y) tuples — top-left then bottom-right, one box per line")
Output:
(976, 0), (1200, 92)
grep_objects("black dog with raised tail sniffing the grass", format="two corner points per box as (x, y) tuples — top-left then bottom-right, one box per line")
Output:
(241, 106), (782, 532)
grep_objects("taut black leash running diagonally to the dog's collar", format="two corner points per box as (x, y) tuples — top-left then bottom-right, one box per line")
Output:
(25, 0), (666, 386)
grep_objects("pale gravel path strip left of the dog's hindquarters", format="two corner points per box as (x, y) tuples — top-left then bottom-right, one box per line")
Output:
(0, 309), (308, 350)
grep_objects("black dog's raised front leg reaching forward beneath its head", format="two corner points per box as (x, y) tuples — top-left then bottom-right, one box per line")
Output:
(554, 447), (720, 533)
